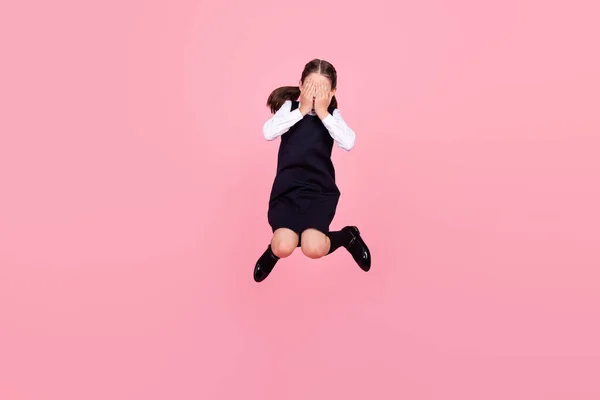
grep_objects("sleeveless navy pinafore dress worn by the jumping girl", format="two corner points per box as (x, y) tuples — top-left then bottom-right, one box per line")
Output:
(268, 101), (340, 234)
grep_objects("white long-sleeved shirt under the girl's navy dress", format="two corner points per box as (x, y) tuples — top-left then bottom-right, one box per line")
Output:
(263, 100), (356, 151)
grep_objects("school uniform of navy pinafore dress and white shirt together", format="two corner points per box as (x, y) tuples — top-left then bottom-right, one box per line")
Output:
(263, 101), (355, 234)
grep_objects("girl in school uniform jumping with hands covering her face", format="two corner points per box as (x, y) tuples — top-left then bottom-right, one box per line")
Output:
(254, 59), (371, 282)
